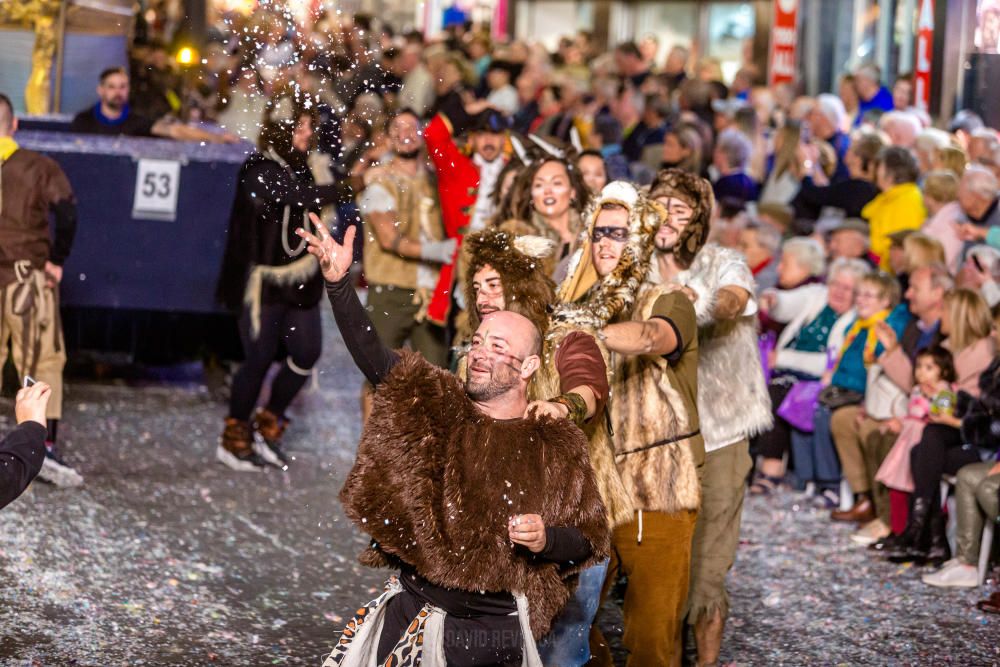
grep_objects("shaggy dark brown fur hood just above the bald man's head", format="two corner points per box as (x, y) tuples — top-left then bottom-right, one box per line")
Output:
(462, 229), (556, 335)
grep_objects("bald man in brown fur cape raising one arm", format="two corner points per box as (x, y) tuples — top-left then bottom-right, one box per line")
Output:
(300, 222), (609, 667)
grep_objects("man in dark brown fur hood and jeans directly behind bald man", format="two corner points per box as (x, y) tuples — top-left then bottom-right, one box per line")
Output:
(463, 229), (632, 667)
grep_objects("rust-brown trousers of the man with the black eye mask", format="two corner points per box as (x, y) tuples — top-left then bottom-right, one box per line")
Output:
(590, 510), (698, 667)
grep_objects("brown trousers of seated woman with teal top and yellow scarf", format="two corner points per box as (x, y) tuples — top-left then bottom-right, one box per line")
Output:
(830, 405), (896, 525)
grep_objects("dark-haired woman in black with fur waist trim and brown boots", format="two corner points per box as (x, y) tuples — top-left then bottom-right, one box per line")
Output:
(216, 95), (343, 471)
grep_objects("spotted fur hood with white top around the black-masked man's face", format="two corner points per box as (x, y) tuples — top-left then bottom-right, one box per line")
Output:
(554, 181), (666, 330)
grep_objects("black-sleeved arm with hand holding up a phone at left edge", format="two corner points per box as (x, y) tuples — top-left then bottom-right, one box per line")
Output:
(0, 382), (52, 509)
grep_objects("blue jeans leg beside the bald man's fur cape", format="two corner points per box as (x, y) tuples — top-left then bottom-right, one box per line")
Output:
(538, 560), (608, 667)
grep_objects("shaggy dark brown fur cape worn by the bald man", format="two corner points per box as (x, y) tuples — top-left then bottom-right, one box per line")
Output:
(340, 352), (610, 639)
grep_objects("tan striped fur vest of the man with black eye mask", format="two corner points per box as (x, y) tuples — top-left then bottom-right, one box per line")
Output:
(610, 283), (705, 513)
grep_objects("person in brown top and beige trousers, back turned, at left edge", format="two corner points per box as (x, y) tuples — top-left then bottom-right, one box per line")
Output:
(0, 94), (83, 486)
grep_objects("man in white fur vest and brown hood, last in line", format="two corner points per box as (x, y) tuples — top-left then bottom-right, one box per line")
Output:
(649, 169), (773, 665)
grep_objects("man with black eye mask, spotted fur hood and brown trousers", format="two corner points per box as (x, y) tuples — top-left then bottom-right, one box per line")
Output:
(553, 181), (704, 665)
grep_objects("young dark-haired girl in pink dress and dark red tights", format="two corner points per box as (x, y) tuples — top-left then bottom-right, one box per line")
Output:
(875, 346), (955, 534)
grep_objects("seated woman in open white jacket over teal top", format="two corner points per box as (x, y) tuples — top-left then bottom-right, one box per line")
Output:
(750, 259), (869, 494)
